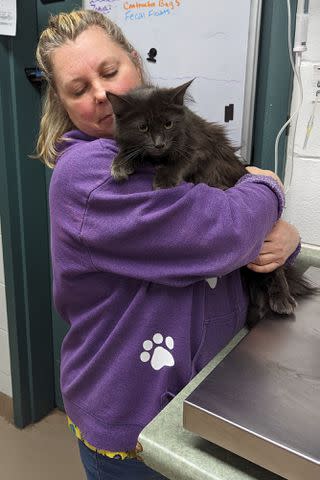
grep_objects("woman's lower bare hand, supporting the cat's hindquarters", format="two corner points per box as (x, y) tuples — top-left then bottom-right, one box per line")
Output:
(247, 219), (300, 273)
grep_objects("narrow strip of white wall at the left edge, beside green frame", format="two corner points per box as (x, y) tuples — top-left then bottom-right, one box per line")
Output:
(0, 223), (12, 397)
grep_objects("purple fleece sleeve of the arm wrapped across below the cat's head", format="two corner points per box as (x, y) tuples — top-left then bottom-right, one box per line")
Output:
(81, 171), (284, 287)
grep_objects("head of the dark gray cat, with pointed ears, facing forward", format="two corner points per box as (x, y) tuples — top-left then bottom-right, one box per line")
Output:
(106, 80), (193, 158)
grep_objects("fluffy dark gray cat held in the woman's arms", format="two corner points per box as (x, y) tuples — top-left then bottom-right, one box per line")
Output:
(107, 81), (317, 327)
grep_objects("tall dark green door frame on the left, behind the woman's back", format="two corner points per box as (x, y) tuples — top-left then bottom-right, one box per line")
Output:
(0, 0), (54, 428)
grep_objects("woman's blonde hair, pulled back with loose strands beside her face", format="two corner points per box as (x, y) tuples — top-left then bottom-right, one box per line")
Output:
(36, 10), (145, 168)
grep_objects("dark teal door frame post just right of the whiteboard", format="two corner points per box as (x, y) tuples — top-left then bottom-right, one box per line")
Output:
(251, 0), (298, 181)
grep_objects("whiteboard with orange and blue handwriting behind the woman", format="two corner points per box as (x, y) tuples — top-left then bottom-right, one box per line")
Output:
(83, 0), (260, 160)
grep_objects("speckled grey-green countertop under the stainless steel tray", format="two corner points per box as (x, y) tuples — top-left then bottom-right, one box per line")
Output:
(139, 247), (320, 480)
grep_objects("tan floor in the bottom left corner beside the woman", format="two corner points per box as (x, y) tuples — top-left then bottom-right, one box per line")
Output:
(0, 410), (86, 480)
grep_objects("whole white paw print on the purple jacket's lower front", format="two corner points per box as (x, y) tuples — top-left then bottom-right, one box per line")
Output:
(140, 333), (174, 370)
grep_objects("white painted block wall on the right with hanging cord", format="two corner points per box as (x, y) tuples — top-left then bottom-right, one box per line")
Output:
(284, 0), (320, 247)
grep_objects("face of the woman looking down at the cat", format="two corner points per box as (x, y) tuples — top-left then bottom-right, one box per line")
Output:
(52, 27), (141, 137)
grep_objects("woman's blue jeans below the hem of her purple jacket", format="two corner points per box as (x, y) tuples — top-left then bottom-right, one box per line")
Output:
(79, 440), (166, 480)
